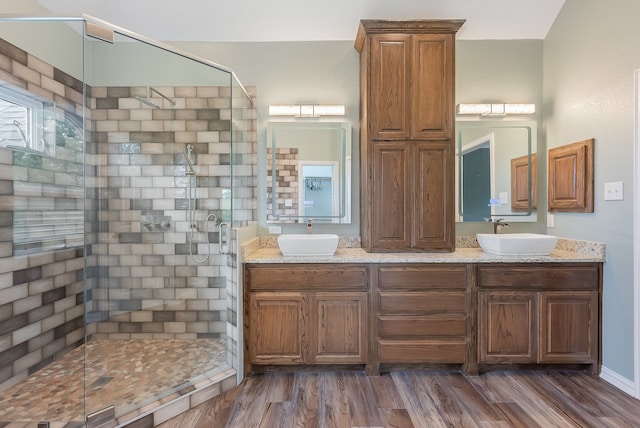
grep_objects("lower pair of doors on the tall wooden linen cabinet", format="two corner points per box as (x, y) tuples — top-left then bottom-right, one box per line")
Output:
(368, 141), (455, 251)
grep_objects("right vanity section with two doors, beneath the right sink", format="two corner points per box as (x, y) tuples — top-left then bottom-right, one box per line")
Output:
(478, 263), (602, 374)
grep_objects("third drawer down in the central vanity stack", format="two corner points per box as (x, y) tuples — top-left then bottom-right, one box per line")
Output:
(378, 314), (467, 339)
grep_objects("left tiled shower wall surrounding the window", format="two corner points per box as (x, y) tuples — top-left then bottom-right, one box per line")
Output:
(0, 39), (84, 391)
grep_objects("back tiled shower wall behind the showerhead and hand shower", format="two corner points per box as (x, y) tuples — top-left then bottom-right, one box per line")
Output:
(91, 86), (251, 339)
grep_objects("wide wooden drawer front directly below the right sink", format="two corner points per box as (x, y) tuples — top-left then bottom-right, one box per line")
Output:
(478, 263), (600, 290)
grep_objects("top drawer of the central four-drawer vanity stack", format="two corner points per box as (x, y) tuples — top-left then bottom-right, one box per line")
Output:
(378, 264), (467, 290)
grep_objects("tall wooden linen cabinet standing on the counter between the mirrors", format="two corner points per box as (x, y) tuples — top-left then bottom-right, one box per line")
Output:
(355, 20), (464, 252)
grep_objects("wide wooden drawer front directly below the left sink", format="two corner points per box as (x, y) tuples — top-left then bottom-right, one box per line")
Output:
(245, 264), (369, 291)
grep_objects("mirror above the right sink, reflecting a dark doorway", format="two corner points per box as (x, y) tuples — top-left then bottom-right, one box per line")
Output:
(456, 120), (537, 222)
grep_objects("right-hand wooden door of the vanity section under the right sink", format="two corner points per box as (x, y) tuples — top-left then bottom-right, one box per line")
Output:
(540, 291), (598, 363)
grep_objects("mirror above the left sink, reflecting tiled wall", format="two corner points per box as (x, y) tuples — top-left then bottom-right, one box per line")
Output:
(267, 122), (351, 224)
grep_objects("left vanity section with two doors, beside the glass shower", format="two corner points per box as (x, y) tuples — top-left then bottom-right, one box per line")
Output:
(244, 264), (369, 372)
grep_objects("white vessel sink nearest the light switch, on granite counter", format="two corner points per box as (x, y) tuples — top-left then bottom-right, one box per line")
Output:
(476, 233), (558, 256)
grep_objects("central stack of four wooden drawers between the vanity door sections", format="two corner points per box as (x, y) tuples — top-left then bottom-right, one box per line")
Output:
(375, 264), (470, 365)
